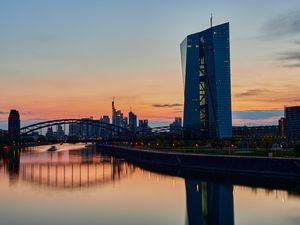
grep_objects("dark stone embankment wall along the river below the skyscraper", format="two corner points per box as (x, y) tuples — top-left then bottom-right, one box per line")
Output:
(98, 144), (300, 179)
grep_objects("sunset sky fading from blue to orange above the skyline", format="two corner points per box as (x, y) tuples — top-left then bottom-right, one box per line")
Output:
(0, 0), (300, 128)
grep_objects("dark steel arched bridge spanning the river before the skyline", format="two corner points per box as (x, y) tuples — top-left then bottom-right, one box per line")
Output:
(0, 119), (205, 142)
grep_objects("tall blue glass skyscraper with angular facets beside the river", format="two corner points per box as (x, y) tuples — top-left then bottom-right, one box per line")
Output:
(180, 23), (232, 138)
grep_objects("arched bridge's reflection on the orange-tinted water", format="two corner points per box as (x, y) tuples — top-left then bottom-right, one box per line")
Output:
(3, 149), (135, 189)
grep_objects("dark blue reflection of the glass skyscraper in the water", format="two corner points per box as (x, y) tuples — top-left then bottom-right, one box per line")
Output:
(185, 179), (234, 225)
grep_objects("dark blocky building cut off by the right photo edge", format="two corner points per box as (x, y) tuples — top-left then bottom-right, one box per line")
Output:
(284, 106), (300, 138)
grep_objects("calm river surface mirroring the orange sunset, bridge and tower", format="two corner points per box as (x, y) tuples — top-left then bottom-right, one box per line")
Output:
(0, 144), (300, 225)
